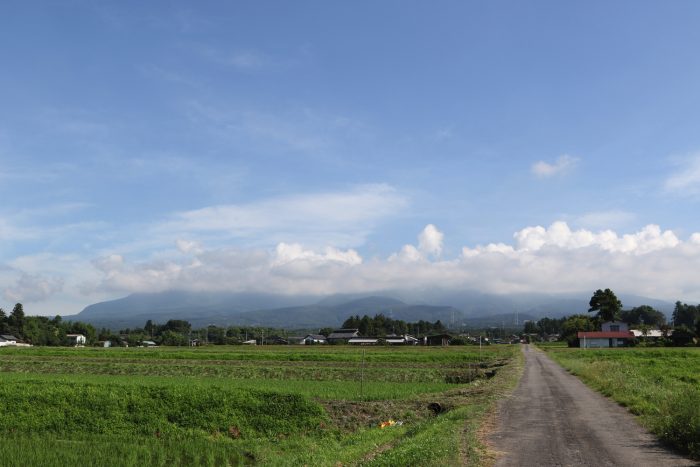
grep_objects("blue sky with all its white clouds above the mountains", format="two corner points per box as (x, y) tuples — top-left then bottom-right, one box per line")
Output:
(0, 1), (700, 314)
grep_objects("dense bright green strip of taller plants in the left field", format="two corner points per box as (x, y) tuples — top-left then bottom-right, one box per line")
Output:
(0, 381), (325, 438)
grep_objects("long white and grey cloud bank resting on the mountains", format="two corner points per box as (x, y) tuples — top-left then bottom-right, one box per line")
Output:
(79, 221), (700, 306)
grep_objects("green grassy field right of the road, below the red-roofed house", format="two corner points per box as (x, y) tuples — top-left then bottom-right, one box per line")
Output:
(543, 346), (700, 459)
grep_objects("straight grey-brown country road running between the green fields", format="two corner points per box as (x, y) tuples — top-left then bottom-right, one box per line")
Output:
(490, 345), (700, 467)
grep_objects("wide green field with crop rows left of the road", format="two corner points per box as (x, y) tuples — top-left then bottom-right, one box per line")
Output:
(0, 346), (520, 465)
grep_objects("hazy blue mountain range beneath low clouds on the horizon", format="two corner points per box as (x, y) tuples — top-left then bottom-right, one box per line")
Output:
(64, 290), (673, 330)
